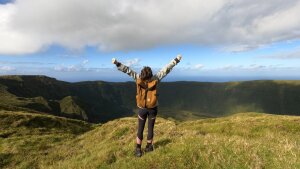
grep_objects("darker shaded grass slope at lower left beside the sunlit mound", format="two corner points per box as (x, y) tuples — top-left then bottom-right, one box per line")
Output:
(0, 111), (92, 168)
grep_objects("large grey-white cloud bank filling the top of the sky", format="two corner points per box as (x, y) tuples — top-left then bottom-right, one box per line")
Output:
(0, 0), (300, 54)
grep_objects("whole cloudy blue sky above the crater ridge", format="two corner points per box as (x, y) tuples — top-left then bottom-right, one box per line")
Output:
(0, 0), (300, 82)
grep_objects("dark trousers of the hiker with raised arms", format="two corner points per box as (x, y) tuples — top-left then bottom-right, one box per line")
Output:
(137, 107), (157, 140)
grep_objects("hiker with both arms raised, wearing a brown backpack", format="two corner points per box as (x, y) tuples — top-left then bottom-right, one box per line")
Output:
(112, 55), (182, 157)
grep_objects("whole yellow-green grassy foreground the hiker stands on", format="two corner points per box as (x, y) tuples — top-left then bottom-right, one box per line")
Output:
(0, 111), (300, 169)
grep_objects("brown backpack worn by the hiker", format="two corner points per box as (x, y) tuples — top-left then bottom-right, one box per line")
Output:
(136, 79), (158, 108)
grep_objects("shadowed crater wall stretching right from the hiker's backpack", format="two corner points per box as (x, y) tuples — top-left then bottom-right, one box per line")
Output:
(160, 81), (300, 116)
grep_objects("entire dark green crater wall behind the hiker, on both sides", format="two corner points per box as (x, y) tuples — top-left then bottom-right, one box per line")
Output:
(0, 76), (300, 123)
